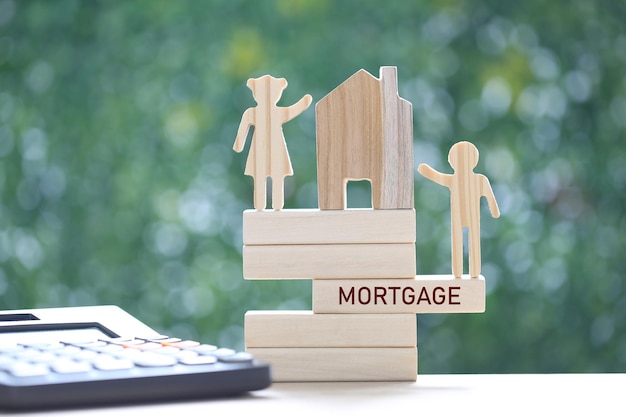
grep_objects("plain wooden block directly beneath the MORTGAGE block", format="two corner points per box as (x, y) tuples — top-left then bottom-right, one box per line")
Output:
(245, 311), (417, 348)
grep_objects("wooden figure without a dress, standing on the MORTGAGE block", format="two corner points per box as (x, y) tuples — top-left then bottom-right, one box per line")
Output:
(417, 142), (500, 278)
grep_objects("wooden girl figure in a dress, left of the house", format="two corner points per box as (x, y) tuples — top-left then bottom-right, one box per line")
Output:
(233, 75), (312, 210)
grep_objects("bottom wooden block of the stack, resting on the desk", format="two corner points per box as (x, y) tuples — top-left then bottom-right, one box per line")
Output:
(247, 347), (417, 382)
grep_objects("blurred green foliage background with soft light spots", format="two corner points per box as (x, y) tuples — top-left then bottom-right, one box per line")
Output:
(0, 0), (626, 373)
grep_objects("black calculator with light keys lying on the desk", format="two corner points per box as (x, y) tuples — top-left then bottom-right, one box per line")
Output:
(0, 306), (271, 409)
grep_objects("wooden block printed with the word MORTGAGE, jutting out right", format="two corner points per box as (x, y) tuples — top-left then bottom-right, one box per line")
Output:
(313, 275), (486, 313)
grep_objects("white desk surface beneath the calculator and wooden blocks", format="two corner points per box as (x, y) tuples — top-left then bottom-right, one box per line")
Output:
(7, 374), (626, 417)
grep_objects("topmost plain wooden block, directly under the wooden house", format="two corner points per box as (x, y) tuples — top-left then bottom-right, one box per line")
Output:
(243, 209), (415, 245)
